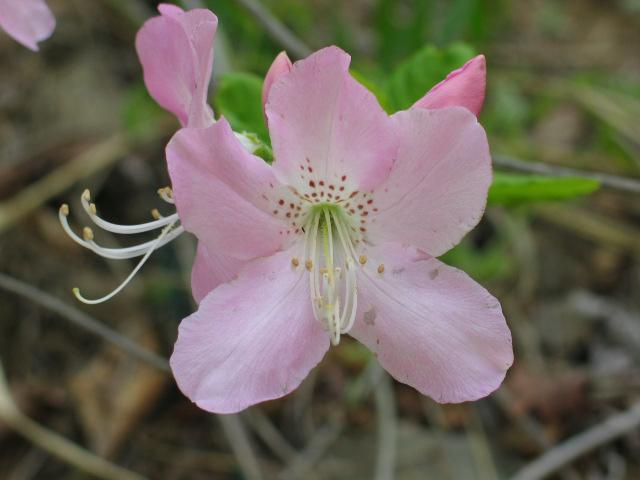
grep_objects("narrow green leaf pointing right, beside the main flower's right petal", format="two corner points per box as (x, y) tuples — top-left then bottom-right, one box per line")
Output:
(489, 172), (600, 206)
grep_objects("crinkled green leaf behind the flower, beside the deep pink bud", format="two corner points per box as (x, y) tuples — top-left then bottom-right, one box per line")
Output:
(386, 43), (475, 111)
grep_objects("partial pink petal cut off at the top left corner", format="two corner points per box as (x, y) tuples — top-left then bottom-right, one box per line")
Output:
(0, 0), (56, 51)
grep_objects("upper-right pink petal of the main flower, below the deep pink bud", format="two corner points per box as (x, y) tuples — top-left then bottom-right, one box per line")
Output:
(369, 107), (491, 257)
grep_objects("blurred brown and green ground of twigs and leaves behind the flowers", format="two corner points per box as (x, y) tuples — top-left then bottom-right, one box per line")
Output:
(0, 0), (640, 480)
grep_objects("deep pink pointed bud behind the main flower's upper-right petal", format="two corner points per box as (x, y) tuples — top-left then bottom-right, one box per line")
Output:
(411, 55), (487, 116)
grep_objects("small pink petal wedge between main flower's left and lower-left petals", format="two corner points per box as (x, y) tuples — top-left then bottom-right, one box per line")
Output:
(191, 242), (247, 303)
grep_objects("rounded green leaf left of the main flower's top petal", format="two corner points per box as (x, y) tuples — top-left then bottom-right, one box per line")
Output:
(214, 72), (269, 145)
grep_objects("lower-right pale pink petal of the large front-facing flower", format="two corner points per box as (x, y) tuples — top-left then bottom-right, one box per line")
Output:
(350, 244), (513, 403)
